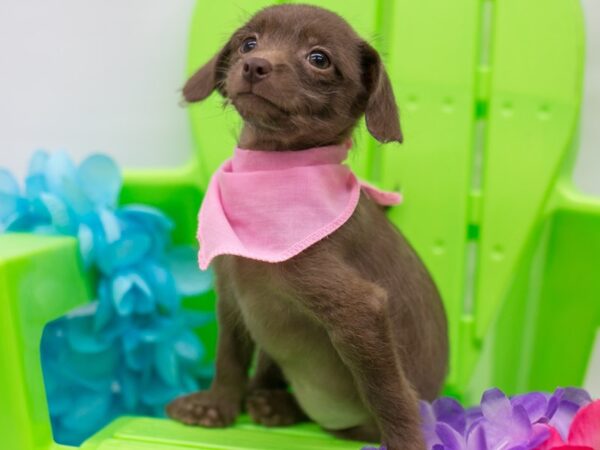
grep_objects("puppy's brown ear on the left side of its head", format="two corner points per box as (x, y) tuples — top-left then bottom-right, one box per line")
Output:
(183, 43), (230, 103)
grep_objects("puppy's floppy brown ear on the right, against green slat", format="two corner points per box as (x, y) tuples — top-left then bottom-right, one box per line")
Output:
(360, 42), (403, 143)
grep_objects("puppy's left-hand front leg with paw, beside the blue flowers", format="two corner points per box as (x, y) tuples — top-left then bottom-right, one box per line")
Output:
(167, 285), (254, 427)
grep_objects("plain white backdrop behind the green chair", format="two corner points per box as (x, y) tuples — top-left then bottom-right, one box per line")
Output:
(0, 0), (600, 396)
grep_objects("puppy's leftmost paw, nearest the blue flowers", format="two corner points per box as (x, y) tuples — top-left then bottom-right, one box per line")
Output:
(166, 390), (240, 428)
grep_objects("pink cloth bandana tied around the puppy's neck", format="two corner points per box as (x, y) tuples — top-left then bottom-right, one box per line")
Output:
(198, 144), (402, 270)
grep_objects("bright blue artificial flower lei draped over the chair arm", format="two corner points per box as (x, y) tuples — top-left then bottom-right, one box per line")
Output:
(0, 151), (214, 445)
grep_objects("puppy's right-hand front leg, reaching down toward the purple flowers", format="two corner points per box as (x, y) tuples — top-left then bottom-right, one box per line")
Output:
(288, 252), (425, 450)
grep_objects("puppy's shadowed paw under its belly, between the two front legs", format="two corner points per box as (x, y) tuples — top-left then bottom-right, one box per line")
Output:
(246, 389), (308, 427)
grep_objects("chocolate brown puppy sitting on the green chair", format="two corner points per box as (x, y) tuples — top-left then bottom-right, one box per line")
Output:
(167, 5), (448, 450)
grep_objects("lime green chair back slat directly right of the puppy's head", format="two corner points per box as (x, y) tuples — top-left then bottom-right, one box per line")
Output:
(380, 0), (480, 383)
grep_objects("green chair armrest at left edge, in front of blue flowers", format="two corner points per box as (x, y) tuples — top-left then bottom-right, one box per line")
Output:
(0, 234), (90, 450)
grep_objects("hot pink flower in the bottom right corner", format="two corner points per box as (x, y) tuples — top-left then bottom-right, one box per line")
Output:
(536, 400), (600, 450)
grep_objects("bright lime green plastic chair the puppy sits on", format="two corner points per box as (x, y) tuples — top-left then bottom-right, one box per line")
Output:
(0, 0), (600, 450)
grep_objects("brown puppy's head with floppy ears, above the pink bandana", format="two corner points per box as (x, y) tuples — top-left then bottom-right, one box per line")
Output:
(183, 5), (402, 148)
